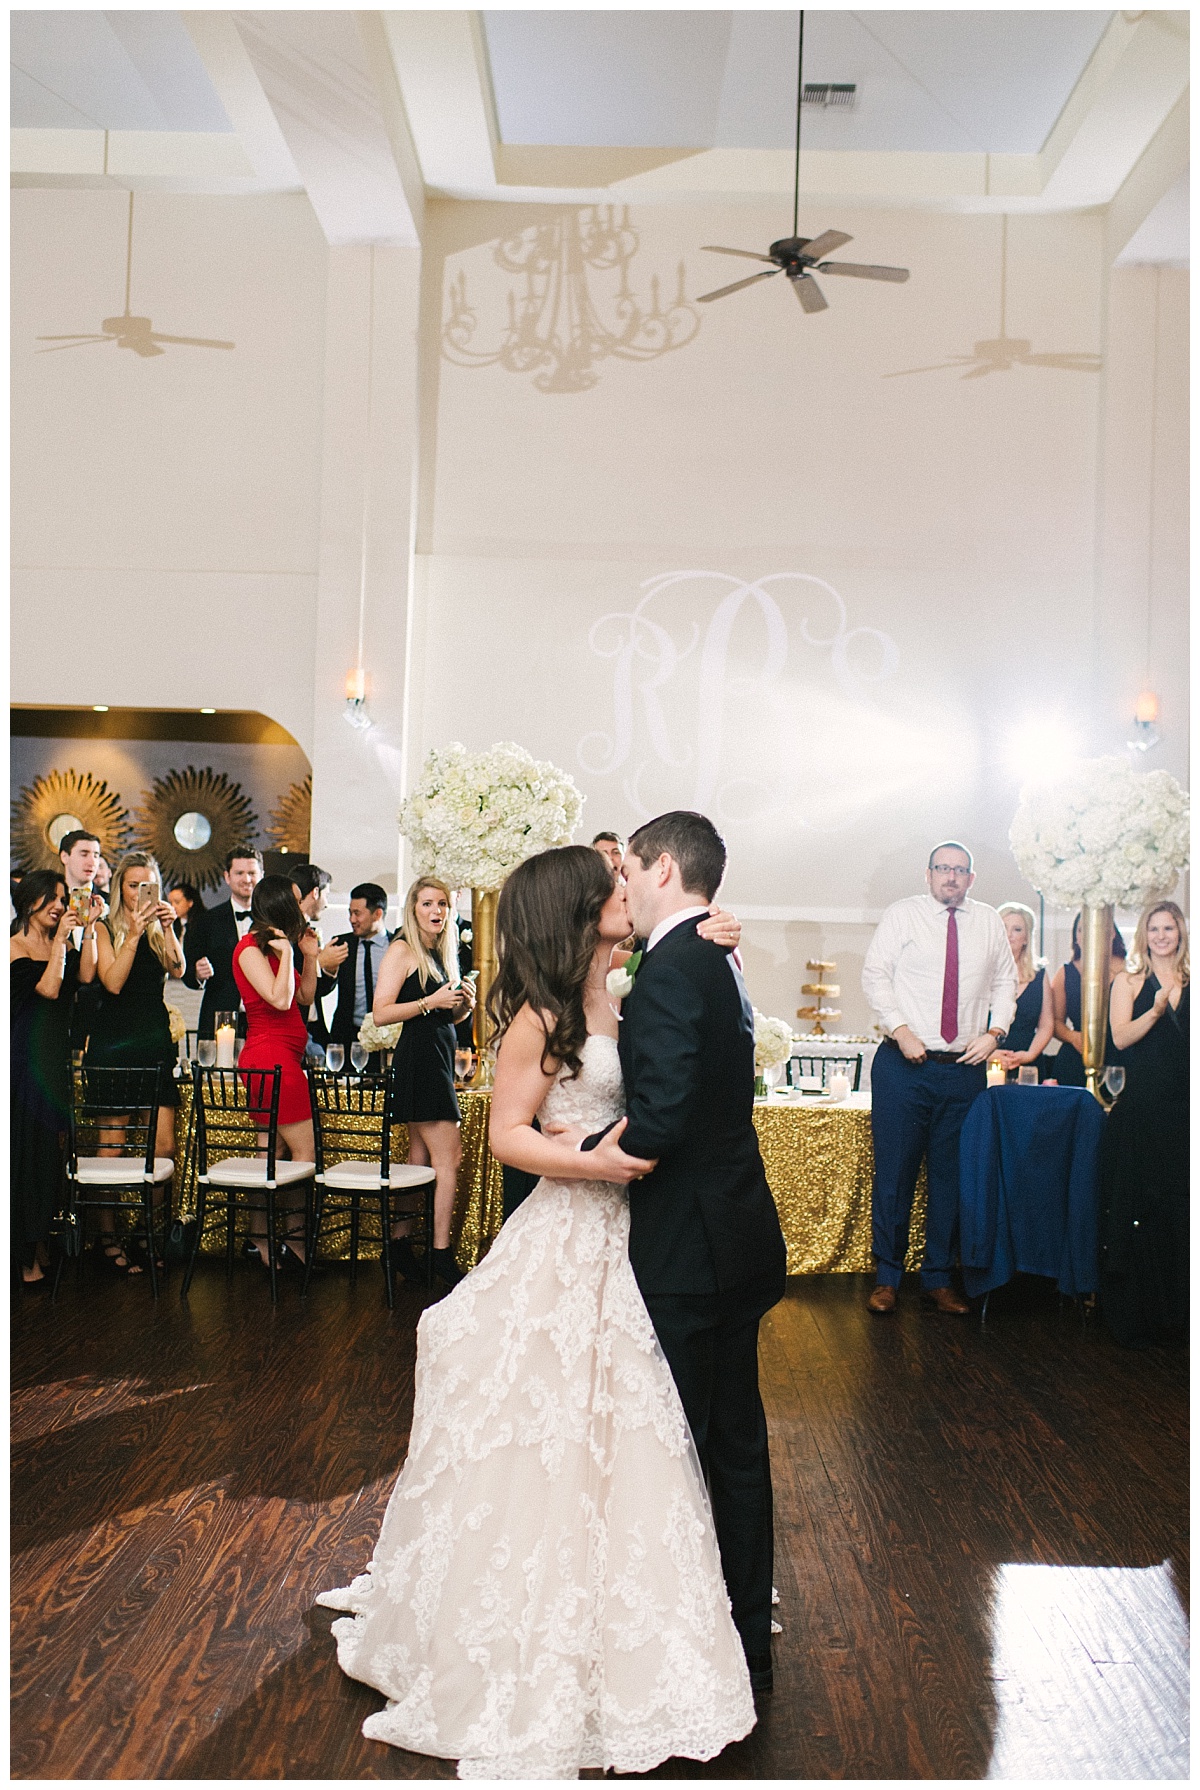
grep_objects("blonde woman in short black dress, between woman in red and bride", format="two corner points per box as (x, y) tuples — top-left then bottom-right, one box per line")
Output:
(373, 877), (475, 1287)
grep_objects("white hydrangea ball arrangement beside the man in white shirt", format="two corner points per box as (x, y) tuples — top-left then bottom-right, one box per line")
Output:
(1008, 757), (1189, 908)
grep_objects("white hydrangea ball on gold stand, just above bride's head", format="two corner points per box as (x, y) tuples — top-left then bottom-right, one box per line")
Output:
(398, 739), (584, 890)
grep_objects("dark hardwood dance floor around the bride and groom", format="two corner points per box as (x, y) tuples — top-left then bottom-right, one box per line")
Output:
(11, 1262), (1187, 1779)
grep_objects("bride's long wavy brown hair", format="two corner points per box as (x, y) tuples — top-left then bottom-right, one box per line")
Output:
(487, 845), (613, 1078)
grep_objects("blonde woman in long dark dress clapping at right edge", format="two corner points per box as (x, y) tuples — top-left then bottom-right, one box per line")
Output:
(1100, 900), (1191, 1348)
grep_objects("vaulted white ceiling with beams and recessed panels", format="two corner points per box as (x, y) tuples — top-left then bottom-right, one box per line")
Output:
(11, 7), (1189, 260)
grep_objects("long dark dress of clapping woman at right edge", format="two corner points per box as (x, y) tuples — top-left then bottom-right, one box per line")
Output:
(1100, 976), (1191, 1348)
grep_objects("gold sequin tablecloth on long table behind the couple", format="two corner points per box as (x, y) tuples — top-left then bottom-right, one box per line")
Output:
(176, 1085), (926, 1274)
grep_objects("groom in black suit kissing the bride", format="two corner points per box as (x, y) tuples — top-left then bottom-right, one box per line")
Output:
(582, 813), (786, 1692)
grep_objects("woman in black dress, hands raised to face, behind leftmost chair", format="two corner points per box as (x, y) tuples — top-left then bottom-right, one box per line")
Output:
(84, 852), (183, 1274)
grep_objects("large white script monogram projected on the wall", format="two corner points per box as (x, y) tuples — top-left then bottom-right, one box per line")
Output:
(577, 571), (899, 823)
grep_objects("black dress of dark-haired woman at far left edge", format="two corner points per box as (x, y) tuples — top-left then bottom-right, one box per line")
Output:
(9, 950), (79, 1267)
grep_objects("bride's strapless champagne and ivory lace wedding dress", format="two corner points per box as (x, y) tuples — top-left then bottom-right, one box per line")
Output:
(319, 1035), (754, 1777)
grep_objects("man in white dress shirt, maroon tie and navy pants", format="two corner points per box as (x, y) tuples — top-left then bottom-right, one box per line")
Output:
(863, 840), (1017, 1316)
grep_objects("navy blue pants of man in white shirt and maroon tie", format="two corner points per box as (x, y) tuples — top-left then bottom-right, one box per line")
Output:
(870, 1044), (987, 1287)
